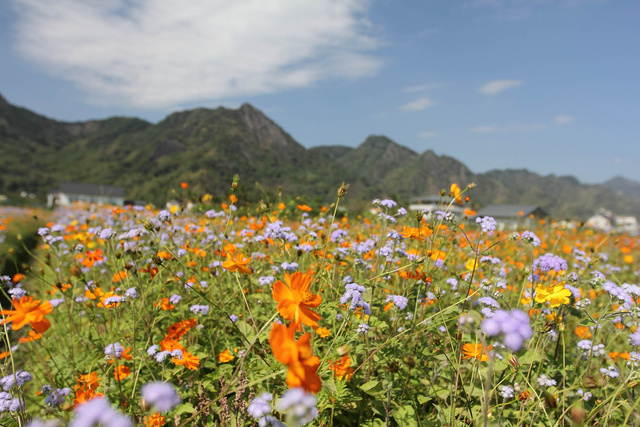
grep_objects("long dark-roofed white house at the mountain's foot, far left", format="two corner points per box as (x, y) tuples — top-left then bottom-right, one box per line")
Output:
(47, 182), (124, 207)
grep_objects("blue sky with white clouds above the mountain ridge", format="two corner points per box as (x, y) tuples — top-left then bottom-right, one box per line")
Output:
(0, 0), (640, 184)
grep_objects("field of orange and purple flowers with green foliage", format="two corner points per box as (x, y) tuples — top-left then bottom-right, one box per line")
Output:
(0, 184), (640, 426)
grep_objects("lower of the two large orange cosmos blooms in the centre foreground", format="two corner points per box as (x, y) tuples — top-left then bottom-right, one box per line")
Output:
(269, 323), (322, 393)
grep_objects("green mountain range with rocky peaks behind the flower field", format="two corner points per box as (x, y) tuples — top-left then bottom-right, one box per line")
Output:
(0, 95), (640, 218)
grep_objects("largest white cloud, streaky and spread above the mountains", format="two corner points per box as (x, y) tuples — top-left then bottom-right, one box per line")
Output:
(15, 0), (382, 108)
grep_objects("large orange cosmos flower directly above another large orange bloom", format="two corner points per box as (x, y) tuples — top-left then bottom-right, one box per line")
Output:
(273, 271), (322, 331)
